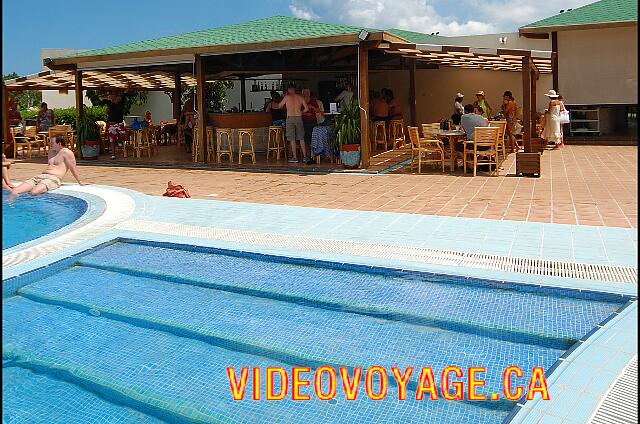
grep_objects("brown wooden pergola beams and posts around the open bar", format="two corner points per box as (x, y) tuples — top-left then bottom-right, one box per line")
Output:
(3, 19), (553, 172)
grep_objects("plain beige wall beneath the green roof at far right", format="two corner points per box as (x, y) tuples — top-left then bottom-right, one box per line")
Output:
(558, 25), (638, 105)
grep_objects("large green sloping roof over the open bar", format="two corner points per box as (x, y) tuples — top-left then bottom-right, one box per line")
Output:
(64, 16), (379, 57)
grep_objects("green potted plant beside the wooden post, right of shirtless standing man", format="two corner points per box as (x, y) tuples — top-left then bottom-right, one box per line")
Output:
(335, 99), (360, 168)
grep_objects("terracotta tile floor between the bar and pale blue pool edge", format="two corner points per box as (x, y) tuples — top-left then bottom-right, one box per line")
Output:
(11, 146), (638, 227)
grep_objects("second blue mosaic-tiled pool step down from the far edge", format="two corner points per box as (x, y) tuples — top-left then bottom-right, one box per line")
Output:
(18, 267), (568, 393)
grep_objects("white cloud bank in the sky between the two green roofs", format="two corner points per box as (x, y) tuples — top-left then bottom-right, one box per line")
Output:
(289, 0), (592, 36)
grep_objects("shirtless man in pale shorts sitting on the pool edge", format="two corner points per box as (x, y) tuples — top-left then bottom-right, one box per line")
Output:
(11, 136), (86, 196)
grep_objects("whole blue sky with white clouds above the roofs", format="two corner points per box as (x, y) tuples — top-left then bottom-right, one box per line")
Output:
(2, 0), (593, 75)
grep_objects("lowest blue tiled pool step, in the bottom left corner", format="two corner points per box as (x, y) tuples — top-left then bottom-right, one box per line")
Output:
(2, 366), (165, 424)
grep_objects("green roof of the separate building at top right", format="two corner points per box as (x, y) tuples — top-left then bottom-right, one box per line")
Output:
(522, 0), (638, 29)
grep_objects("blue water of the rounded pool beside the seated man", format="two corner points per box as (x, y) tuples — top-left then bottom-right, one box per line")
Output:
(2, 190), (87, 249)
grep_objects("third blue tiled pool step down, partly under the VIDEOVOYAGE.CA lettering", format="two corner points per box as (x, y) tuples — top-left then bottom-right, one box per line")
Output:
(2, 296), (506, 423)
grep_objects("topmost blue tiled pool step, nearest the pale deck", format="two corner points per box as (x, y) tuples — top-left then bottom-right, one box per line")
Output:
(79, 243), (623, 346)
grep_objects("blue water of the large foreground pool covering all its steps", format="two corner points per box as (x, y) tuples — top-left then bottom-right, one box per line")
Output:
(3, 241), (628, 424)
